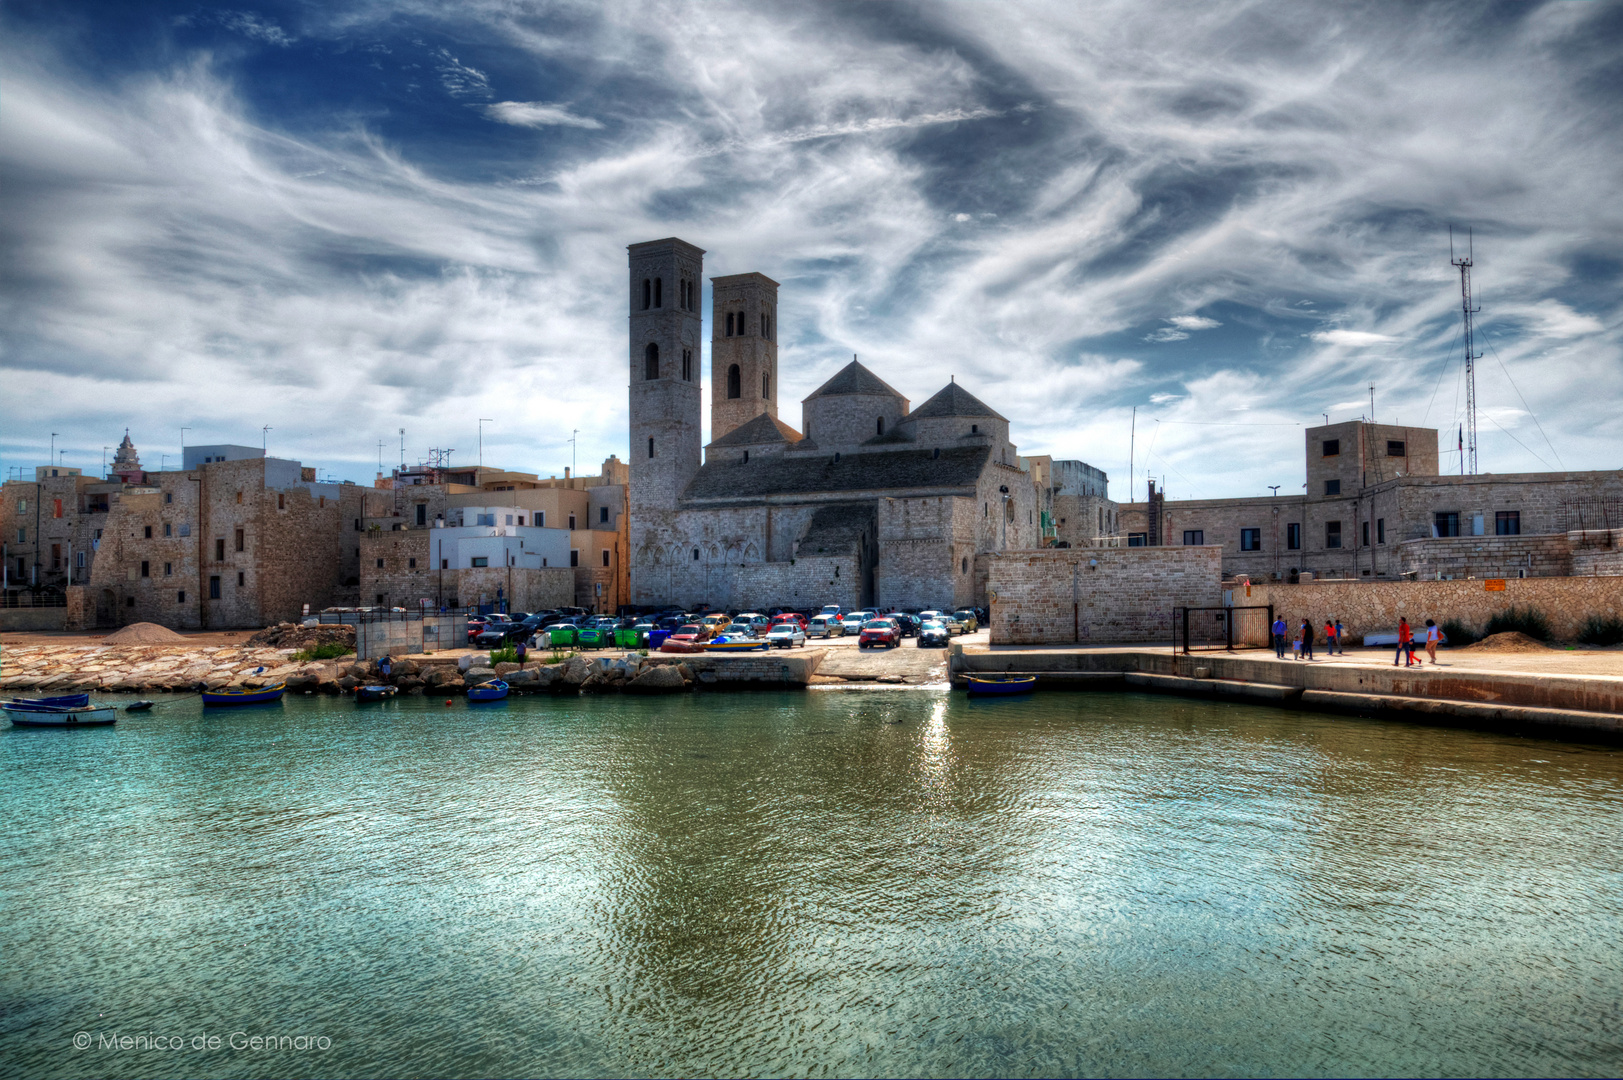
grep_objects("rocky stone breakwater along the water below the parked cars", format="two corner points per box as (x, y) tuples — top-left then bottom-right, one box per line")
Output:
(0, 645), (823, 695)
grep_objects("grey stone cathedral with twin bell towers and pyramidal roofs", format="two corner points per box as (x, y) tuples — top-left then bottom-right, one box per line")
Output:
(628, 237), (1104, 611)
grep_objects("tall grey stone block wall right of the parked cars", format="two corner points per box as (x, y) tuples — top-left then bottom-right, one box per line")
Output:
(985, 547), (1222, 645)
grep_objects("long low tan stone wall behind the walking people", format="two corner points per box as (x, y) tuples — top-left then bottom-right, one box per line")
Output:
(1235, 578), (1623, 645)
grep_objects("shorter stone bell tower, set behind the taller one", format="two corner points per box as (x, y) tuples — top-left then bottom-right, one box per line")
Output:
(711, 273), (777, 440)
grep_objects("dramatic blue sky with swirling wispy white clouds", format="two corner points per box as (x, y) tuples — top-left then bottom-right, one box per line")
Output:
(0, 0), (1623, 499)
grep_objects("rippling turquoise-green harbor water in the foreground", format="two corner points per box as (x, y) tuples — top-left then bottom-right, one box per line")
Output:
(0, 692), (1623, 1077)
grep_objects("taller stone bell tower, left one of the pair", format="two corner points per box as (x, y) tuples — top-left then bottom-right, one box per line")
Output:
(628, 237), (704, 522)
